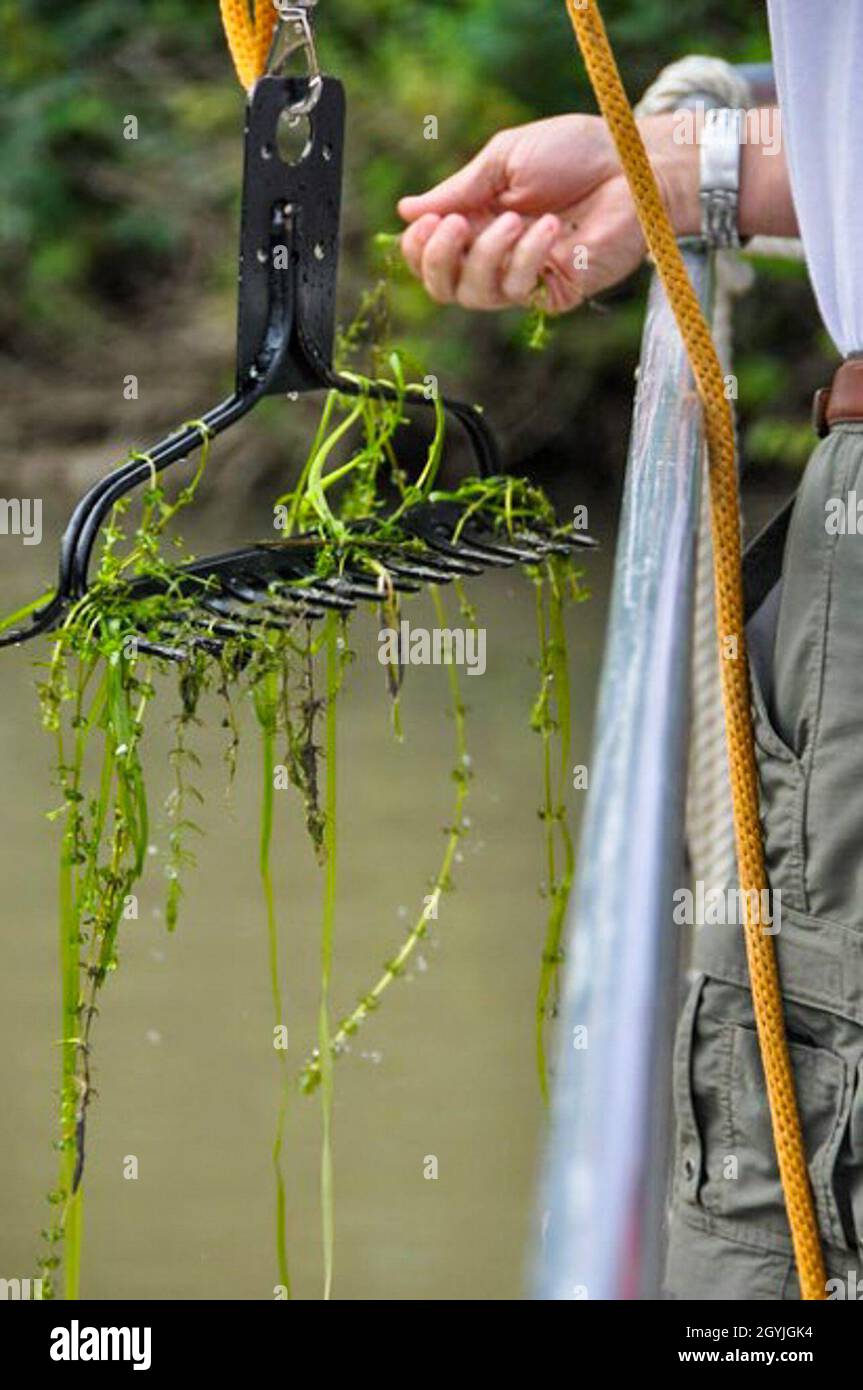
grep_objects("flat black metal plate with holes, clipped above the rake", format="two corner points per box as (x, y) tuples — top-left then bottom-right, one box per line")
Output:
(238, 76), (345, 395)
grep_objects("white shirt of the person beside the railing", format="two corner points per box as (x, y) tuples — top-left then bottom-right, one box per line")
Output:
(767, 0), (863, 354)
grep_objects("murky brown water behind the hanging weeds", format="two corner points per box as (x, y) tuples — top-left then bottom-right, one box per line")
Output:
(0, 500), (610, 1300)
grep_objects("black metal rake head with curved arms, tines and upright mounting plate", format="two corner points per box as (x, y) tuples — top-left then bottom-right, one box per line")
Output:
(0, 76), (593, 659)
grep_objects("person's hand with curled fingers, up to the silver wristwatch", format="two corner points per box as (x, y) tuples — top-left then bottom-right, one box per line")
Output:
(399, 115), (698, 313)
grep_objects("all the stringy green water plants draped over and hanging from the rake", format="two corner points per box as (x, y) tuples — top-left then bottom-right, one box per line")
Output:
(16, 262), (582, 1298)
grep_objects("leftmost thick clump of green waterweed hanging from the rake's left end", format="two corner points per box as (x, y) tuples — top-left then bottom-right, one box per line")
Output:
(39, 448), (214, 1298)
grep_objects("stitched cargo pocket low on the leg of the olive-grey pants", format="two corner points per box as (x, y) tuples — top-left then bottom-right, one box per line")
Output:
(675, 977), (853, 1248)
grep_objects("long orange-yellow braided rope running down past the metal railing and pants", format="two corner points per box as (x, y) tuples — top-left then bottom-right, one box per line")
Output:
(567, 0), (827, 1300)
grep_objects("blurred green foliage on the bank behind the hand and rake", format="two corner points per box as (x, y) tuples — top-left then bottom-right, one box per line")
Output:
(0, 0), (823, 480)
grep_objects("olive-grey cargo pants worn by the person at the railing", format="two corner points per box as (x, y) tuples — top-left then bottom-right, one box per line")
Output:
(667, 425), (863, 1300)
